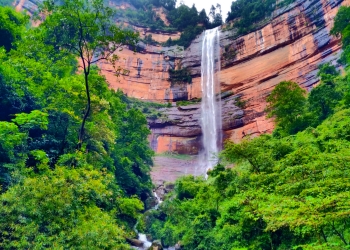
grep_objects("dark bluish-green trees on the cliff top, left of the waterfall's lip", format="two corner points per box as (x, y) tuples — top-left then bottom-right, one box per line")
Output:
(117, 0), (223, 47)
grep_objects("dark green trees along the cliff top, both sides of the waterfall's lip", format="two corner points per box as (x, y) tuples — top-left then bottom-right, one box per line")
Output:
(117, 0), (293, 47)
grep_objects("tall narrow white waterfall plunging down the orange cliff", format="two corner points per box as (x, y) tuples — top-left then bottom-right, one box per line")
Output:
(200, 28), (222, 173)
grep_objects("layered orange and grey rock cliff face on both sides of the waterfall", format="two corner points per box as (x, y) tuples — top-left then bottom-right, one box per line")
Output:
(17, 0), (350, 154)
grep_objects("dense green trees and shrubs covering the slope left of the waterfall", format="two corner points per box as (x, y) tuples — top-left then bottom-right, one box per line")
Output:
(0, 0), (153, 249)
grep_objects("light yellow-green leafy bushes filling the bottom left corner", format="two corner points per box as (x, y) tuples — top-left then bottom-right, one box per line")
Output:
(0, 167), (138, 249)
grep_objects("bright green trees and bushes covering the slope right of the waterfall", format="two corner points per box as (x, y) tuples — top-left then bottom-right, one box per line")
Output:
(144, 7), (350, 250)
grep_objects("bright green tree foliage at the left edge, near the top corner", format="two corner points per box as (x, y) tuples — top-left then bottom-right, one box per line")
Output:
(0, 7), (29, 51)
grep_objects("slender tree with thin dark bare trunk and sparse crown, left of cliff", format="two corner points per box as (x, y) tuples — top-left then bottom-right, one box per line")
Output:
(40, 0), (138, 149)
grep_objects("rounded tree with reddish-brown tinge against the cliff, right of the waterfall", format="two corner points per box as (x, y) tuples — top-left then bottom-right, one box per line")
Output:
(266, 81), (306, 133)
